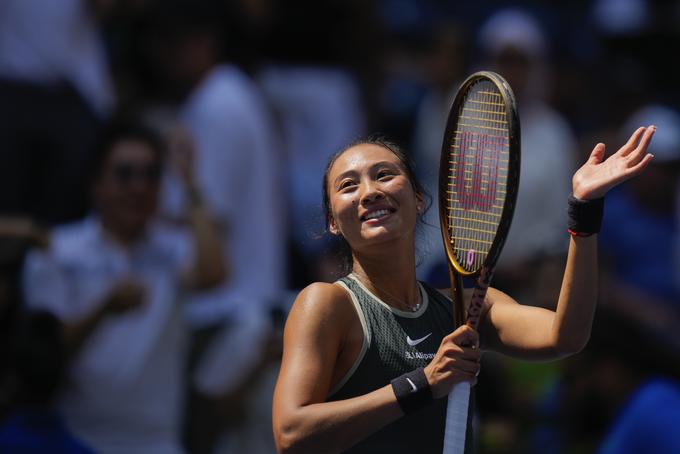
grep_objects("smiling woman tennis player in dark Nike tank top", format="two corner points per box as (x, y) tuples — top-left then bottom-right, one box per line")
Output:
(273, 126), (656, 454)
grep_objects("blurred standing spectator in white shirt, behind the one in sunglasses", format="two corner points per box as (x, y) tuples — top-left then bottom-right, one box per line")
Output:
(139, 0), (286, 453)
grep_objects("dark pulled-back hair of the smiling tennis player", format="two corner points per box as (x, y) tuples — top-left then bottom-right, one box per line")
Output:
(321, 135), (431, 274)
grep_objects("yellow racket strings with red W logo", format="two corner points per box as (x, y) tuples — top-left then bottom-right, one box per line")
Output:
(447, 81), (509, 272)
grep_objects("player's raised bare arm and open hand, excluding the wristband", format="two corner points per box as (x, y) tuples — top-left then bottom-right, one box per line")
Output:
(480, 126), (656, 359)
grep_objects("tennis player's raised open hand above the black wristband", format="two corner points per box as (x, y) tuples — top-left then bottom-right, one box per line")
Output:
(572, 126), (656, 200)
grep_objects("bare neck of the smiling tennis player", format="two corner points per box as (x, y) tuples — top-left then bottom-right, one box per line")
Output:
(352, 238), (420, 310)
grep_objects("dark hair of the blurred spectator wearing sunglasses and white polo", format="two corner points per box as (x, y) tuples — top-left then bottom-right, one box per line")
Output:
(90, 116), (165, 183)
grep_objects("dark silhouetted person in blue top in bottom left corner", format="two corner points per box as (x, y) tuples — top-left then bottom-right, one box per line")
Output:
(0, 311), (94, 454)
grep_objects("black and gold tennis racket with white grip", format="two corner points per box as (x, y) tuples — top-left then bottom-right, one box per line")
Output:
(439, 71), (520, 454)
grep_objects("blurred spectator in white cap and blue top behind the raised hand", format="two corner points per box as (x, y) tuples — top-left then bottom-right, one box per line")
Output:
(601, 104), (680, 302)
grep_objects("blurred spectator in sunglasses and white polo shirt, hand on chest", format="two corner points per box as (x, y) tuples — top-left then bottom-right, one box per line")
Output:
(24, 119), (224, 453)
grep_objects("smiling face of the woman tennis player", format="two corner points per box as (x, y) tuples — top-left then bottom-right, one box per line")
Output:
(328, 144), (422, 250)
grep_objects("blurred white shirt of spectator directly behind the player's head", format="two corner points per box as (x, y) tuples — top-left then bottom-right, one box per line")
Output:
(259, 62), (364, 286)
